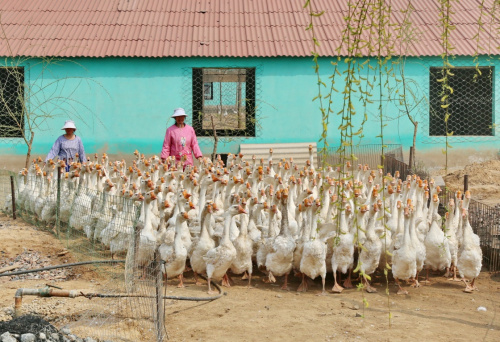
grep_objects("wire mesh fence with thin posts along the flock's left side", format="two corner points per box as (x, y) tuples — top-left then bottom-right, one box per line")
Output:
(0, 171), (171, 341)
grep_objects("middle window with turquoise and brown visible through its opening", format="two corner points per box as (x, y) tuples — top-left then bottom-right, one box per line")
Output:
(193, 68), (255, 137)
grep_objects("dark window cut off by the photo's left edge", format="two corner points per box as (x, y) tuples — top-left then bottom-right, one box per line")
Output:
(0, 67), (24, 138)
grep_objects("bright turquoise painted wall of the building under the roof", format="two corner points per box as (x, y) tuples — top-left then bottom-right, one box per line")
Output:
(0, 57), (498, 155)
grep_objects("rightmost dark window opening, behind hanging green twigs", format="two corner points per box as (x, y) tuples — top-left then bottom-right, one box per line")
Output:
(429, 67), (495, 136)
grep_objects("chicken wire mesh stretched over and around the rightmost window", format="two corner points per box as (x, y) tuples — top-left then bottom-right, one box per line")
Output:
(417, 56), (500, 145)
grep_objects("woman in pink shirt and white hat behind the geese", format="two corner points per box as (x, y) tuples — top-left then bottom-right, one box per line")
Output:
(161, 108), (203, 166)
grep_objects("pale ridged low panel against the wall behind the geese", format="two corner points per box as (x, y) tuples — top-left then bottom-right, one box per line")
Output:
(240, 142), (318, 167)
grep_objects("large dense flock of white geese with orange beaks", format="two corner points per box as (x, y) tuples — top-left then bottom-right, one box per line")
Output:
(6, 148), (482, 294)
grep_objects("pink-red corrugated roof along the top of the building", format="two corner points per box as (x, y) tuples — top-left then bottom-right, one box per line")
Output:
(0, 0), (500, 57)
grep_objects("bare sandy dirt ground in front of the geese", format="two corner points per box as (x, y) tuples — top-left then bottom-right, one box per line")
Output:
(0, 214), (500, 341)
